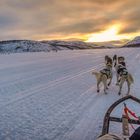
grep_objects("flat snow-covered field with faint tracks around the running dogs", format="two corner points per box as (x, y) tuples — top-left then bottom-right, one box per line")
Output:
(0, 48), (140, 140)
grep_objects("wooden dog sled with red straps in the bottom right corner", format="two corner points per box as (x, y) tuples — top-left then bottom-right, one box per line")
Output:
(101, 95), (140, 140)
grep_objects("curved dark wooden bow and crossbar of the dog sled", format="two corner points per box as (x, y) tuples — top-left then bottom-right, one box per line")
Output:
(102, 95), (140, 135)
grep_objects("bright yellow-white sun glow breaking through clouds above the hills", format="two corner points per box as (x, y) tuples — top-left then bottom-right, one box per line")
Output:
(86, 24), (124, 42)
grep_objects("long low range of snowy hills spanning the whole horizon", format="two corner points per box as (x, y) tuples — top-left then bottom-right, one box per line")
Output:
(0, 37), (136, 53)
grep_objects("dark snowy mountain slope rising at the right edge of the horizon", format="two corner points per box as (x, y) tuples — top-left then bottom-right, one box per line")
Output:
(123, 36), (140, 47)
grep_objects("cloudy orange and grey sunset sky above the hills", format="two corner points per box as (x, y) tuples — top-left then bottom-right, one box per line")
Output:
(0, 0), (140, 42)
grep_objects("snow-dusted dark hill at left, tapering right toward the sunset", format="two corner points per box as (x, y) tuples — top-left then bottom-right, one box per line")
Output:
(0, 40), (100, 53)
